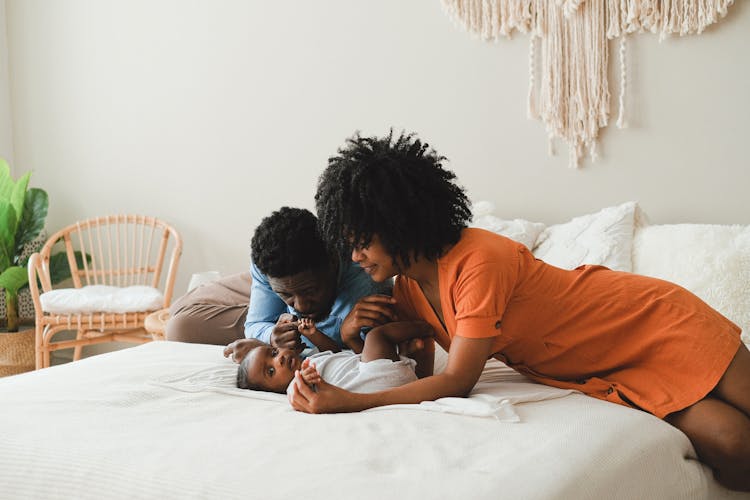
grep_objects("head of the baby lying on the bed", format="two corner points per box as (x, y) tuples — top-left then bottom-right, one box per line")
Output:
(237, 341), (302, 394)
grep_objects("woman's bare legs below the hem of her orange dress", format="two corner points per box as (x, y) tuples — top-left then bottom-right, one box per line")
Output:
(665, 345), (750, 491)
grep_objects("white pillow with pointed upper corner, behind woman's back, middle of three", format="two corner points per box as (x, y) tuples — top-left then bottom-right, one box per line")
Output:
(533, 201), (639, 272)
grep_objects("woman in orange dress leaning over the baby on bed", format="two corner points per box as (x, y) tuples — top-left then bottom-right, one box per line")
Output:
(289, 130), (750, 490)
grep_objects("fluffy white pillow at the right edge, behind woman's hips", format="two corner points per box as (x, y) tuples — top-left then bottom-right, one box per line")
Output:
(633, 224), (750, 343)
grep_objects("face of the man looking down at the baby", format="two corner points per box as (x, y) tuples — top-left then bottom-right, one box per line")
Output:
(268, 266), (337, 321)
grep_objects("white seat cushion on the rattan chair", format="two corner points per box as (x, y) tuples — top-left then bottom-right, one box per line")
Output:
(40, 285), (164, 314)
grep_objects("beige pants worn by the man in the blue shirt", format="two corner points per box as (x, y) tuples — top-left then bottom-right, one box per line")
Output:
(165, 273), (252, 345)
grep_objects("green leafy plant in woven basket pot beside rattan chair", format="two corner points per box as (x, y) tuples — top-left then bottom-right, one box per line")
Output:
(0, 158), (78, 376)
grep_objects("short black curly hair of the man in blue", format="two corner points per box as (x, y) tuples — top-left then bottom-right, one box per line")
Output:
(250, 207), (330, 278)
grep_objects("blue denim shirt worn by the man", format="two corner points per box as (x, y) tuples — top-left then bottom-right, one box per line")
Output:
(245, 260), (393, 347)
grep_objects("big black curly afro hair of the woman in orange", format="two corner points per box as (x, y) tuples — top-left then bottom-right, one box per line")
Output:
(315, 130), (471, 266)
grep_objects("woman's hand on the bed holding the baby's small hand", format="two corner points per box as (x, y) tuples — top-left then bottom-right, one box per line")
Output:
(286, 370), (362, 413)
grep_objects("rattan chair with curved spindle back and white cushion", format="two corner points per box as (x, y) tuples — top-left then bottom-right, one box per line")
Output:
(28, 215), (182, 369)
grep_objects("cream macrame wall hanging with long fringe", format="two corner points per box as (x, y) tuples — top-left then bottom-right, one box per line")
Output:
(443, 0), (734, 167)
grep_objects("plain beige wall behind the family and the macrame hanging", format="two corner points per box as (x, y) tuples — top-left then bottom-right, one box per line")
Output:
(0, 0), (750, 288)
